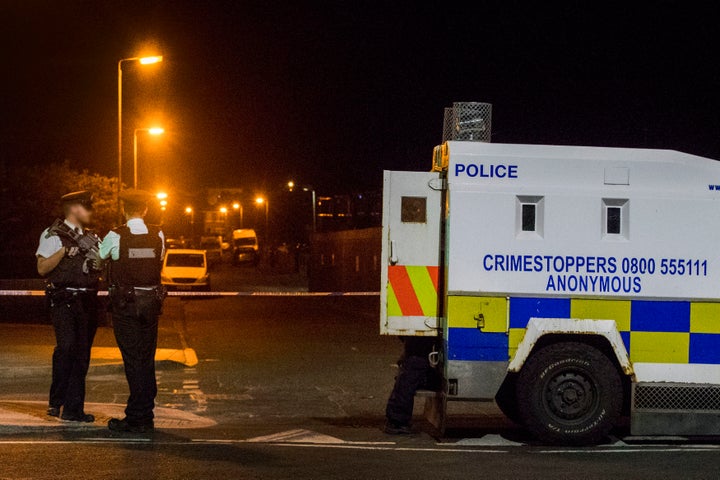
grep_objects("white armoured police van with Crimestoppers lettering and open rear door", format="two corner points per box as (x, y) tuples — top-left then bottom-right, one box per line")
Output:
(380, 103), (720, 444)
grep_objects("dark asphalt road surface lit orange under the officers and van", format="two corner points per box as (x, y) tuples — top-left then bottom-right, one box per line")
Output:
(0, 271), (720, 480)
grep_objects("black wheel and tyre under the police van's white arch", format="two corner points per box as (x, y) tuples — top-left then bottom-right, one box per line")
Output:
(516, 342), (623, 445)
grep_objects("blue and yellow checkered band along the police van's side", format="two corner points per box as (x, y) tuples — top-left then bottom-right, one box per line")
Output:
(446, 296), (720, 364)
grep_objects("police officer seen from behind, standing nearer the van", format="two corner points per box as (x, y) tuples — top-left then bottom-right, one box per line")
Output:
(100, 190), (165, 433)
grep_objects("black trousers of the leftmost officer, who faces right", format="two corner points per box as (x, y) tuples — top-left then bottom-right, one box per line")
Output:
(50, 293), (97, 416)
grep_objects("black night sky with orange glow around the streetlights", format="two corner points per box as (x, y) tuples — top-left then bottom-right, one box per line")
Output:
(0, 0), (720, 193)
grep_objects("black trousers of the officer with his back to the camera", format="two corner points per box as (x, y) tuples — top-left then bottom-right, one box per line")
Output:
(112, 296), (159, 425)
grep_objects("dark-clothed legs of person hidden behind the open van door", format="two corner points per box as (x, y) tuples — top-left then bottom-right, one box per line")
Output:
(383, 337), (440, 435)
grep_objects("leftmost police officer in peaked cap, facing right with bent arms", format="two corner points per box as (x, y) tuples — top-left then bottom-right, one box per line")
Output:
(35, 191), (100, 423)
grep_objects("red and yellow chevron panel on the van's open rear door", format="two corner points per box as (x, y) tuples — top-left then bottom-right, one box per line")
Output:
(387, 265), (439, 317)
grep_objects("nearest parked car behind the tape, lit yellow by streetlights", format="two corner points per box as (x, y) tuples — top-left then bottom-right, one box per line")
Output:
(161, 249), (210, 290)
